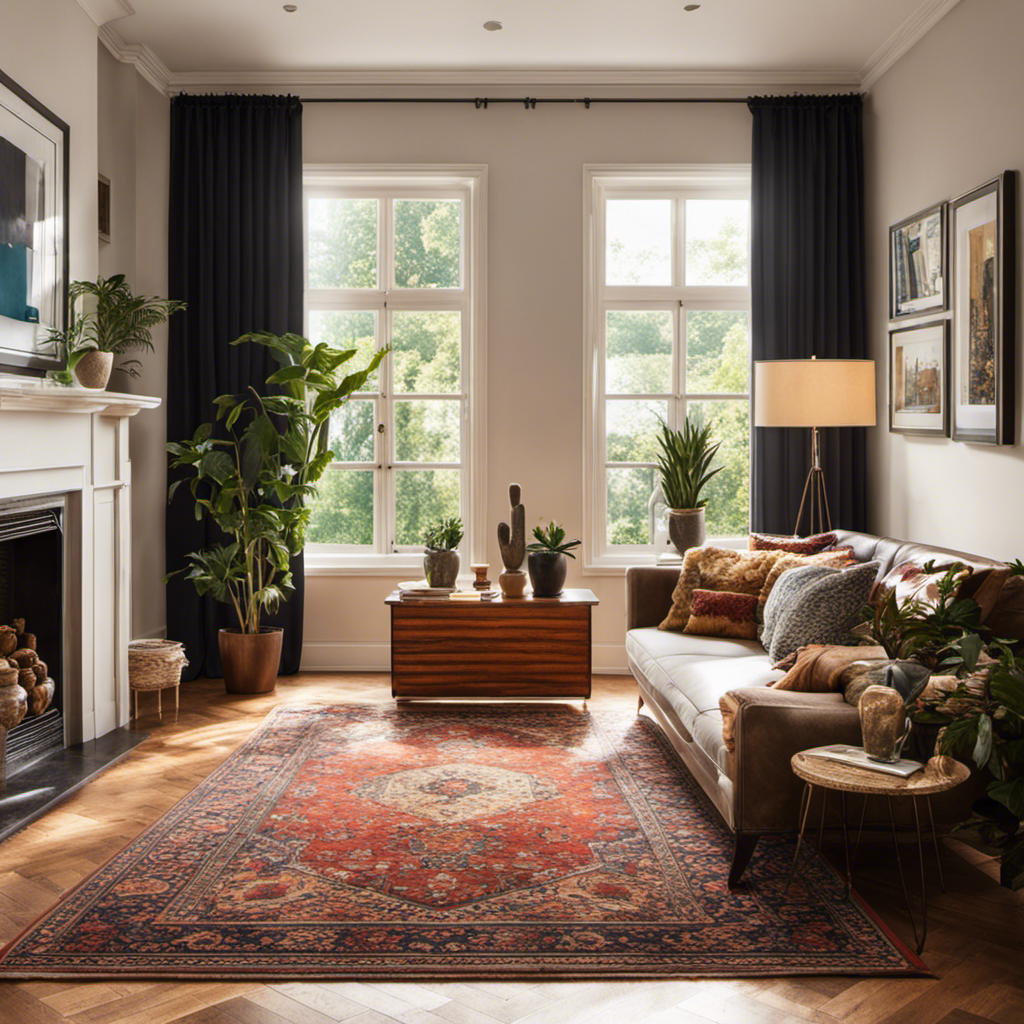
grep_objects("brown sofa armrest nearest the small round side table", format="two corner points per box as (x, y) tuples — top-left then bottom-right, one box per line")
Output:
(732, 687), (860, 833)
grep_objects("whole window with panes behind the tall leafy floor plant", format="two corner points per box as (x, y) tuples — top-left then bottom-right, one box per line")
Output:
(305, 168), (485, 572)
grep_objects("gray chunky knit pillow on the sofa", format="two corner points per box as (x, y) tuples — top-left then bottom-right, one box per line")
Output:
(762, 562), (879, 663)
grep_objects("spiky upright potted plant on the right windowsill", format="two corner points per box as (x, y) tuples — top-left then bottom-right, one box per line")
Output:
(657, 419), (724, 555)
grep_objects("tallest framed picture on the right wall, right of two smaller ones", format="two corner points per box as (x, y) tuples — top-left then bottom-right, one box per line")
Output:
(949, 171), (1017, 444)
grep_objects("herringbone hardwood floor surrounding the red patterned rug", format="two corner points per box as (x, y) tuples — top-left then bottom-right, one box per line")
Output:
(0, 674), (1024, 1024)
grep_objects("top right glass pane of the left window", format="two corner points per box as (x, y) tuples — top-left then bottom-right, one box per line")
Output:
(394, 199), (462, 288)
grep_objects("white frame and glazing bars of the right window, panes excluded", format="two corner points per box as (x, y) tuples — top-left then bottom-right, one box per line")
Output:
(583, 164), (753, 575)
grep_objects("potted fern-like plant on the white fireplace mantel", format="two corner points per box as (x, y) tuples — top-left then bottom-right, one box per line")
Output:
(47, 273), (185, 390)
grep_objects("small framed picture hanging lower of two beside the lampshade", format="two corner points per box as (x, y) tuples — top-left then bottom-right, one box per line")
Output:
(889, 319), (949, 437)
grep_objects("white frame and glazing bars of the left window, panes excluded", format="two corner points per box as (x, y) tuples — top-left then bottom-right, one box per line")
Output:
(303, 164), (487, 577)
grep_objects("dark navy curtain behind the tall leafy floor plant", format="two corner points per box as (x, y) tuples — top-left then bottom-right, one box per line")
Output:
(166, 95), (303, 679)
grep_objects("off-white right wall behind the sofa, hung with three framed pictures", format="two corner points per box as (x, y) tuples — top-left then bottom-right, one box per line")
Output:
(865, 0), (1024, 558)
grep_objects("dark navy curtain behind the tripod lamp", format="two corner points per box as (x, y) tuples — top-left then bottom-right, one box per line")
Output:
(750, 95), (867, 534)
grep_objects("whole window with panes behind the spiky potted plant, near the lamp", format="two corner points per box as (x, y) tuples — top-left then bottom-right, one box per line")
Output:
(585, 167), (751, 568)
